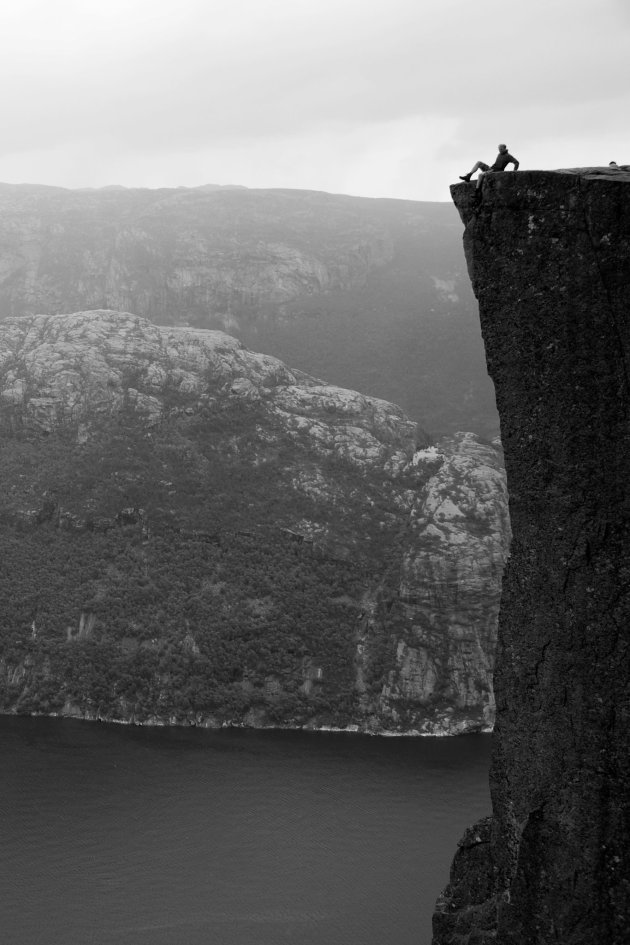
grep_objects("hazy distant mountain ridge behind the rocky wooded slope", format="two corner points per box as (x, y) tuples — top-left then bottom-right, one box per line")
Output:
(0, 184), (498, 438)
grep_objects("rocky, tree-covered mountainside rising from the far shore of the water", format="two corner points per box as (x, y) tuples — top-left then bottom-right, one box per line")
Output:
(0, 311), (509, 733)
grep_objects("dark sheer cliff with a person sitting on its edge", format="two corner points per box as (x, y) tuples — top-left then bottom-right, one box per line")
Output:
(434, 168), (630, 945)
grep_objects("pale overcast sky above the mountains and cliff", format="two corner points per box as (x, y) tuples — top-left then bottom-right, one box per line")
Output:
(0, 0), (630, 200)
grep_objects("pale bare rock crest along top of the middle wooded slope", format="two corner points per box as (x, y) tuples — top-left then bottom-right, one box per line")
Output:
(0, 311), (417, 475)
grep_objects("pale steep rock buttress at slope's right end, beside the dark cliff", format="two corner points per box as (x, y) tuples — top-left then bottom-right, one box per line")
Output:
(382, 433), (510, 731)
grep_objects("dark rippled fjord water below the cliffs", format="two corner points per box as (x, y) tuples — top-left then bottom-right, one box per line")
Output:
(0, 717), (489, 945)
